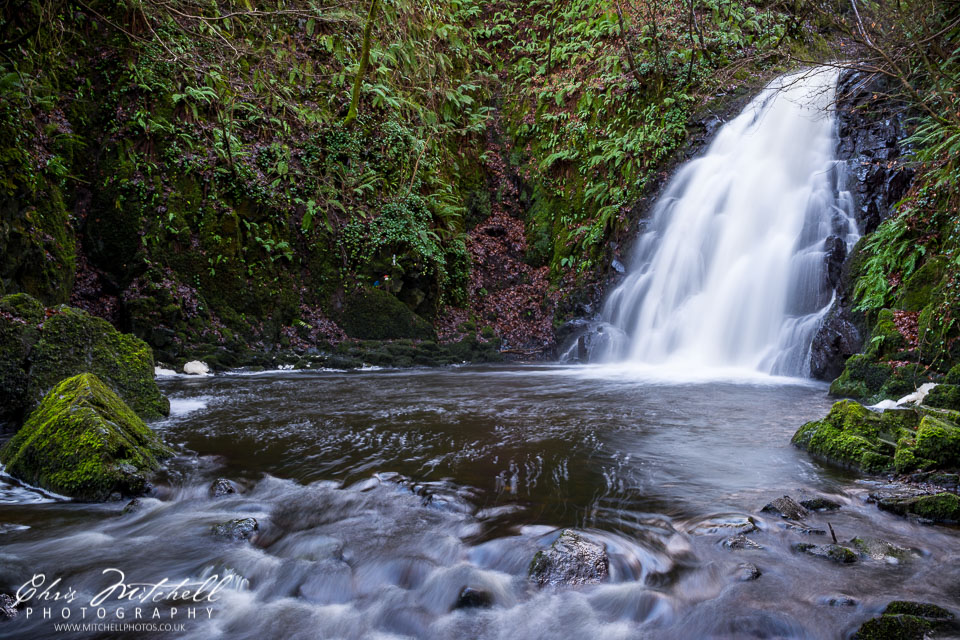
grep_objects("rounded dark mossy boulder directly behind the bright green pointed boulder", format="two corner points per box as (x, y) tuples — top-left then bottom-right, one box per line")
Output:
(29, 307), (170, 420)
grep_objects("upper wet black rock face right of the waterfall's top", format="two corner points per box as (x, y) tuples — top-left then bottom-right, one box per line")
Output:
(837, 70), (914, 234)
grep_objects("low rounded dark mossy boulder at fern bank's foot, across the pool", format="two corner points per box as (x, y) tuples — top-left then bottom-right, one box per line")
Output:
(340, 288), (434, 340)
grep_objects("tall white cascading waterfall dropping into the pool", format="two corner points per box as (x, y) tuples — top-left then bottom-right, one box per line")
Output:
(590, 70), (857, 376)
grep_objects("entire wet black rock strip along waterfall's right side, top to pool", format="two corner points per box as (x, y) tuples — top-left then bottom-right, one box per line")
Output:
(810, 70), (914, 380)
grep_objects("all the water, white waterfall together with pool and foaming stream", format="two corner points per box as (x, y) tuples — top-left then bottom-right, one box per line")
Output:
(0, 73), (960, 640)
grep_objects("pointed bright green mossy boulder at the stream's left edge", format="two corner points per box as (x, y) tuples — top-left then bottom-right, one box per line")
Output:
(0, 373), (172, 501)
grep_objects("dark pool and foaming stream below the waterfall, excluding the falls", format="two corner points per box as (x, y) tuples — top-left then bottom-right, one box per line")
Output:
(0, 366), (960, 640)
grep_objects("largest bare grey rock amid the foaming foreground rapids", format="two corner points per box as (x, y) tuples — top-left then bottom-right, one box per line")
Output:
(528, 529), (610, 587)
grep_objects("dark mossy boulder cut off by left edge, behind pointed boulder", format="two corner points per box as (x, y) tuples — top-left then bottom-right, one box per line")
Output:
(0, 293), (44, 424)
